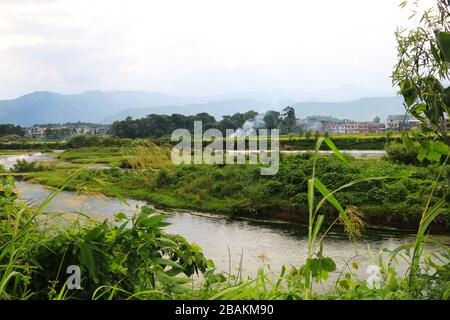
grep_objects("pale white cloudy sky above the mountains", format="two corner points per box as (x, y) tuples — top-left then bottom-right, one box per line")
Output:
(0, 0), (430, 99)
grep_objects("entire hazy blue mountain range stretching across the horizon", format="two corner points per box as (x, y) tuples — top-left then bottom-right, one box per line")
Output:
(0, 88), (404, 126)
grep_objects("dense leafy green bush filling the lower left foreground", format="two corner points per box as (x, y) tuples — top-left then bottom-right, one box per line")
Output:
(0, 179), (214, 299)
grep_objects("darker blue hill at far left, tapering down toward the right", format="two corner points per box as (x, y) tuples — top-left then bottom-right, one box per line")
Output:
(0, 91), (204, 126)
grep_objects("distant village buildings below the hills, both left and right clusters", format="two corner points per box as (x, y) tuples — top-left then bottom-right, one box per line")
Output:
(25, 115), (420, 138)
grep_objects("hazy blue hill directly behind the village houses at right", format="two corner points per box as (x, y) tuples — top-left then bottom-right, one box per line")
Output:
(292, 97), (405, 121)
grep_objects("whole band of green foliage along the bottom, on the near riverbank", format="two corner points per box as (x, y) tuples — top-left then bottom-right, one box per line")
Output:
(0, 179), (450, 299)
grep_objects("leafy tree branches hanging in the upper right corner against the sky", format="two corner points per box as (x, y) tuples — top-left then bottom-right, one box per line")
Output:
(392, 0), (450, 161)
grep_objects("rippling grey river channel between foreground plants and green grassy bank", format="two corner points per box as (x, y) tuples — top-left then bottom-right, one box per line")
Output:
(12, 181), (450, 279)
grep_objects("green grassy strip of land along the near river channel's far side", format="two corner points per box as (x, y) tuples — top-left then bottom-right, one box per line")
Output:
(12, 146), (449, 230)
